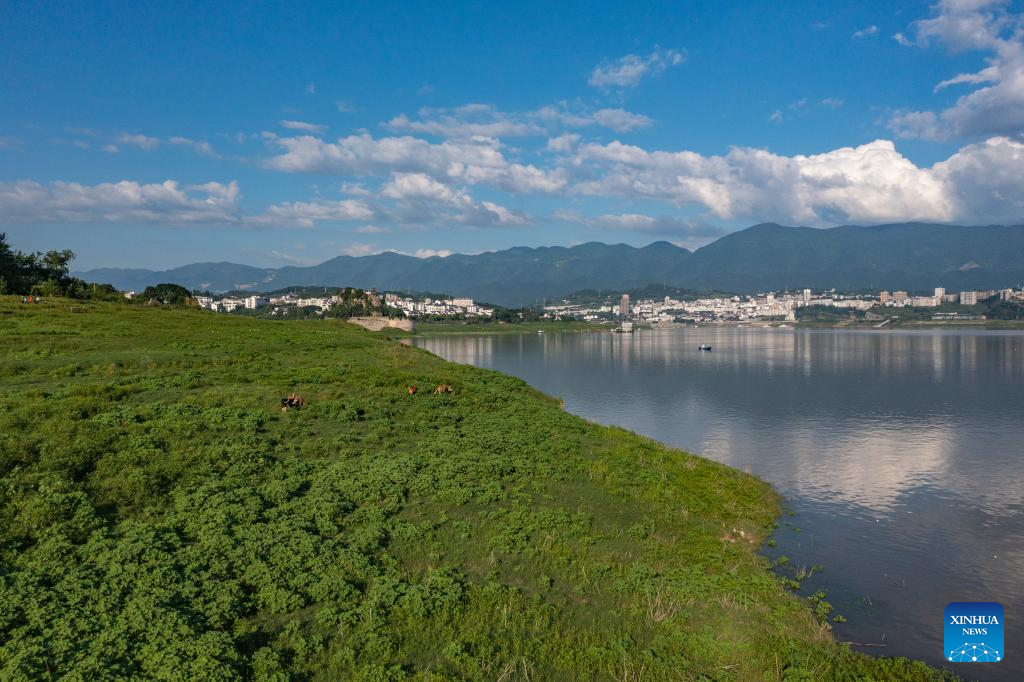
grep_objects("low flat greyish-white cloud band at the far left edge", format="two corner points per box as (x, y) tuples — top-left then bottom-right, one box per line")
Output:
(0, 180), (241, 224)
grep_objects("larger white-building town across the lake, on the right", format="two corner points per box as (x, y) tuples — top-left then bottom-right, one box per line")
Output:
(544, 287), (1024, 324)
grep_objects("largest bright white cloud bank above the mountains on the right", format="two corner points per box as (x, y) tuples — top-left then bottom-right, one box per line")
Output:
(571, 138), (1024, 225)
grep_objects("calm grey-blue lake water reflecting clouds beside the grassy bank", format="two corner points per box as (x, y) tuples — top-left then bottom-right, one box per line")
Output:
(416, 328), (1024, 680)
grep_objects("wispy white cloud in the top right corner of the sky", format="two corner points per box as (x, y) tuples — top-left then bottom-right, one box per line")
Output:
(889, 0), (1024, 141)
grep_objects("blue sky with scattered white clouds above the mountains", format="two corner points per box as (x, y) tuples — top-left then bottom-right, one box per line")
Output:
(0, 0), (1024, 269)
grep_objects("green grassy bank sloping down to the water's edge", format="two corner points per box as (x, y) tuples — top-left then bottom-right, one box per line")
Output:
(0, 298), (950, 680)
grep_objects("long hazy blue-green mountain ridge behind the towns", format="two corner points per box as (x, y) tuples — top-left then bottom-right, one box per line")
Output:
(78, 223), (1024, 305)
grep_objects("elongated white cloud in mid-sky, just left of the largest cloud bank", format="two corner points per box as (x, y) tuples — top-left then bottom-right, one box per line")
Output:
(265, 134), (566, 194)
